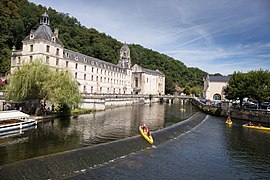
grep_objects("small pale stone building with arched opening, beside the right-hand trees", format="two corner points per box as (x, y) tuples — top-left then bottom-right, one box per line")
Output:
(203, 75), (230, 101)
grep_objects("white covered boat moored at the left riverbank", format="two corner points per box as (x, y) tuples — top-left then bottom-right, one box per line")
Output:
(0, 110), (37, 136)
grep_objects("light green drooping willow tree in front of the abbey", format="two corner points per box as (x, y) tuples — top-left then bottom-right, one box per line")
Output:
(5, 60), (82, 114)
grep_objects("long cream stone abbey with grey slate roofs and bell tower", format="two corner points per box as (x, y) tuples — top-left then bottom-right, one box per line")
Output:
(11, 12), (165, 95)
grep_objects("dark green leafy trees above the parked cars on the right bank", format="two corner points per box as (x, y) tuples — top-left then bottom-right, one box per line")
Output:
(224, 70), (270, 106)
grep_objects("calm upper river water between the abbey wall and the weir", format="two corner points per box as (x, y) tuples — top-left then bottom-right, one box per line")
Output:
(0, 99), (197, 165)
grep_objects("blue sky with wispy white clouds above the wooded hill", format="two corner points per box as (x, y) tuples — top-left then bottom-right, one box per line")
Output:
(30, 0), (270, 75)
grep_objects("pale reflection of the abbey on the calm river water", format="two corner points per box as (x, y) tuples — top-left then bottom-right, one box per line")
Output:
(66, 104), (164, 144)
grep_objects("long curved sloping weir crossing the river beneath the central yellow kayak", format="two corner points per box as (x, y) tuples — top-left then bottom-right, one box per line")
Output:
(0, 112), (206, 179)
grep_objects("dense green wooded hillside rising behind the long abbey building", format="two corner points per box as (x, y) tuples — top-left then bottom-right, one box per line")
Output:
(0, 0), (206, 93)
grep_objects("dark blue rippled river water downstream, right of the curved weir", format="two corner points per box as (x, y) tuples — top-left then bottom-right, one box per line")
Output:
(71, 116), (270, 179)
